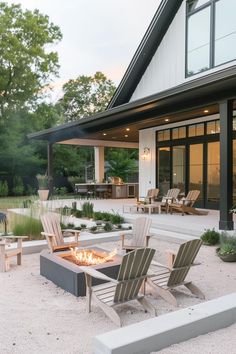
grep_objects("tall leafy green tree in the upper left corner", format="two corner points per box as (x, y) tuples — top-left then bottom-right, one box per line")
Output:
(0, 2), (62, 121)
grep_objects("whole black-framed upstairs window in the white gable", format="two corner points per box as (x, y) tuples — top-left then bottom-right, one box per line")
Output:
(186, 0), (236, 76)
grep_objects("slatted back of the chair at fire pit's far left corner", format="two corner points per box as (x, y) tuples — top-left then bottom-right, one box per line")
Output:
(40, 213), (64, 246)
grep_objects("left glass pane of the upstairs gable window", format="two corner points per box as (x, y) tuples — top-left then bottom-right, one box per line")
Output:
(188, 6), (210, 75)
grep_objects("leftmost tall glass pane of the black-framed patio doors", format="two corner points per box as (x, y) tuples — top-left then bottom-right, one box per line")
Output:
(158, 147), (170, 195)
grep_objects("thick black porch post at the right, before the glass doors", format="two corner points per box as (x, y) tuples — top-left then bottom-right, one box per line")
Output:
(219, 101), (234, 230)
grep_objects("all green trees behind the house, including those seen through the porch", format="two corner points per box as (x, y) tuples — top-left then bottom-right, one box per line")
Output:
(0, 2), (138, 196)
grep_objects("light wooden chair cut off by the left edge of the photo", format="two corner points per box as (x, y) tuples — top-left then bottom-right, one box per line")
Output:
(0, 235), (28, 272)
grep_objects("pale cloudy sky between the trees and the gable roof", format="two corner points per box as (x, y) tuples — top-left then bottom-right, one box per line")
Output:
(8, 0), (160, 99)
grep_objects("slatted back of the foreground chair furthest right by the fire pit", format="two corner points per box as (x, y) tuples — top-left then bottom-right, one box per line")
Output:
(167, 239), (202, 286)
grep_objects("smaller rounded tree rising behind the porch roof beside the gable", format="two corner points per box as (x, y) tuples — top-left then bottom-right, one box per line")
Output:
(61, 72), (115, 122)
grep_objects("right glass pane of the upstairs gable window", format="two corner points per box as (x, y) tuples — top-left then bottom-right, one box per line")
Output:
(215, 0), (236, 65)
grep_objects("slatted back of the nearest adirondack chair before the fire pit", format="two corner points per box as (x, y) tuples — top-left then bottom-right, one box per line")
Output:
(114, 248), (155, 303)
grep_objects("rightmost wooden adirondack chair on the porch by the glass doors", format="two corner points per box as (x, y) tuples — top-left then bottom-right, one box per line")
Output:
(169, 190), (208, 215)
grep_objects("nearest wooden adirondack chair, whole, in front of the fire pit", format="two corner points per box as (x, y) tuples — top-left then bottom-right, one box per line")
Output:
(80, 248), (156, 326)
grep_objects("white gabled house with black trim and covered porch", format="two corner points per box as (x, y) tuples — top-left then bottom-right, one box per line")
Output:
(30, 0), (236, 229)
